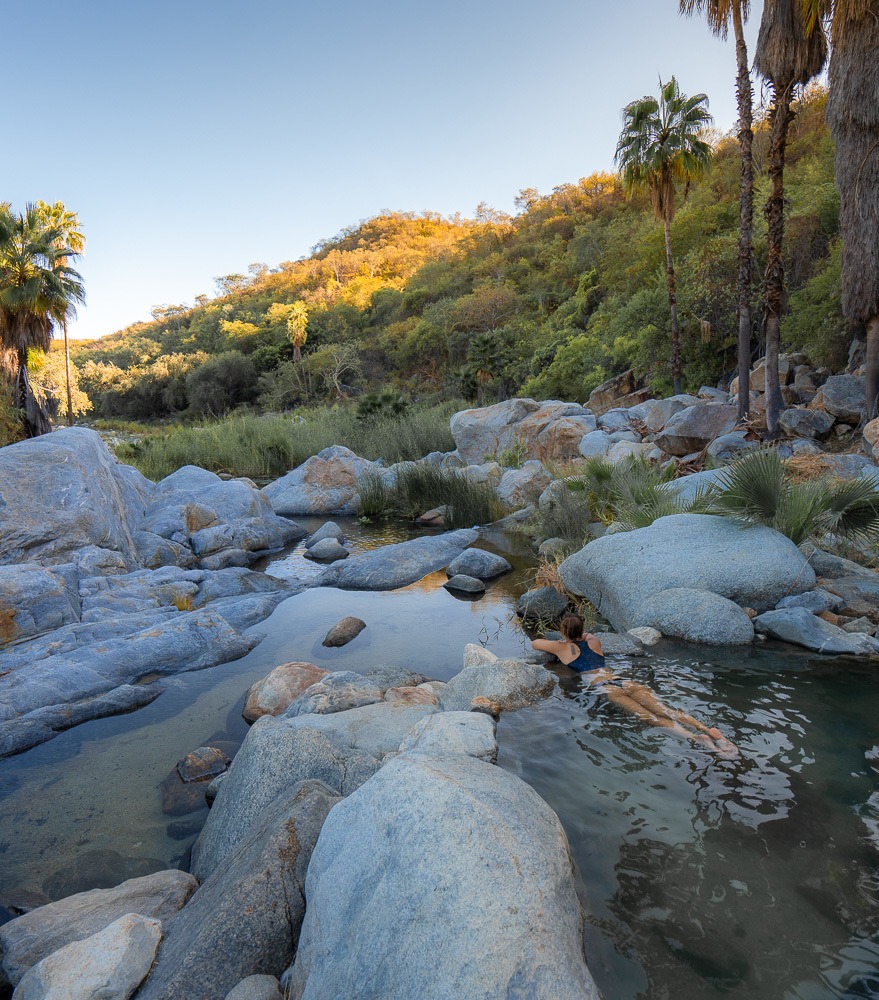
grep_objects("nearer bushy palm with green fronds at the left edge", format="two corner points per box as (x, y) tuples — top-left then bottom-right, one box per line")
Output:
(0, 205), (85, 435)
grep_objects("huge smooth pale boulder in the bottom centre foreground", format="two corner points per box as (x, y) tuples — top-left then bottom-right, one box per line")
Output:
(284, 752), (598, 1000)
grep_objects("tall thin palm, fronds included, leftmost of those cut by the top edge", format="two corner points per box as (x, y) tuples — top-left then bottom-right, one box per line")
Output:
(680, 0), (754, 420)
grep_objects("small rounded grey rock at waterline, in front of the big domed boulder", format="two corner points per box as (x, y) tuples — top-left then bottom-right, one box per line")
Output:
(636, 587), (754, 646)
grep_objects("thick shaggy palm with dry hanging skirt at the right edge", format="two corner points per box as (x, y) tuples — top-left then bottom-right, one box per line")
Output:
(802, 0), (879, 420)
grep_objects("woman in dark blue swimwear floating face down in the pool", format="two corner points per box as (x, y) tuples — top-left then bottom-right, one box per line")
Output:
(531, 615), (738, 756)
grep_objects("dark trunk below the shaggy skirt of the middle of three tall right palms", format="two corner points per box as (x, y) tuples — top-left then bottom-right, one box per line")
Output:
(763, 81), (794, 439)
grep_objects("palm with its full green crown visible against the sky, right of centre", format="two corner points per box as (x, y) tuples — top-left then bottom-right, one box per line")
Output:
(615, 77), (713, 395)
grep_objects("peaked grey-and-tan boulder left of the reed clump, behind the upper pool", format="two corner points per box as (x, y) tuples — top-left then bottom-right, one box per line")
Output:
(263, 445), (380, 517)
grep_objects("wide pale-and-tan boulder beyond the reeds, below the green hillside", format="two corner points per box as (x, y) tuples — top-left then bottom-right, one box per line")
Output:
(450, 399), (597, 464)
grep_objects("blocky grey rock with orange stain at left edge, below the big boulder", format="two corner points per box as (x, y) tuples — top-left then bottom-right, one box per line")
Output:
(0, 563), (81, 647)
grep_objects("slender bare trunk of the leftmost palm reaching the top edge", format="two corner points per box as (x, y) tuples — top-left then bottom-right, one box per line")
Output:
(732, 0), (754, 421)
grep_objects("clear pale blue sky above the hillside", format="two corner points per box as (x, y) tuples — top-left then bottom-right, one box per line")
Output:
(0, 0), (759, 337)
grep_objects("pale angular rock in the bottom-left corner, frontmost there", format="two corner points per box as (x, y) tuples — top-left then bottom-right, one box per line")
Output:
(15, 913), (162, 1000)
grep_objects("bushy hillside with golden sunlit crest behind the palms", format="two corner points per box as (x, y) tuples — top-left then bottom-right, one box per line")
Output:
(75, 90), (851, 419)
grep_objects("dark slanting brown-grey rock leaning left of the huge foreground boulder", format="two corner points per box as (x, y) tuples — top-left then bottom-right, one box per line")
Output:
(138, 781), (339, 1000)
